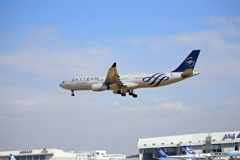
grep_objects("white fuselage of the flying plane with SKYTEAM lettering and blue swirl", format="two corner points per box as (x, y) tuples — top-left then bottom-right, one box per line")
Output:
(60, 72), (199, 91)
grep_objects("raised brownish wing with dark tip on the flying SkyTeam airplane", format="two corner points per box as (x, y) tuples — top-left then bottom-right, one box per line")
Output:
(105, 62), (124, 87)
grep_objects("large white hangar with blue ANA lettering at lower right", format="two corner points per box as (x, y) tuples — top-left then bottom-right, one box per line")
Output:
(138, 131), (240, 160)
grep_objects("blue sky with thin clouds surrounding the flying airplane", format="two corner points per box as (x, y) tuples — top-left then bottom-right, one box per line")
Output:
(0, 0), (240, 155)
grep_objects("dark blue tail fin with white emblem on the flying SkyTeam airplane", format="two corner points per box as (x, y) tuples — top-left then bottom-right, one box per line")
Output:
(172, 50), (200, 72)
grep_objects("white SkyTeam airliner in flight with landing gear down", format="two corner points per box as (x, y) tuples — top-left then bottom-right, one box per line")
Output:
(59, 50), (200, 98)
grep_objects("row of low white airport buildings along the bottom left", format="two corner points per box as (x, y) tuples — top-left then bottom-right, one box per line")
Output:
(0, 149), (126, 160)
